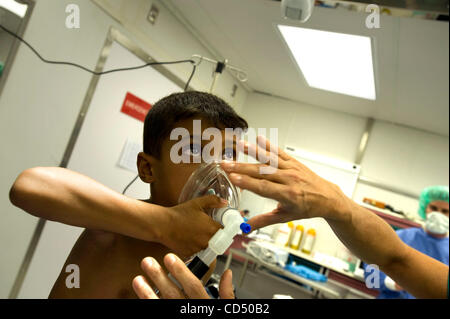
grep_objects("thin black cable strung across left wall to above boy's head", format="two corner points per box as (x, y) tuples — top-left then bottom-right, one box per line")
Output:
(0, 24), (197, 194)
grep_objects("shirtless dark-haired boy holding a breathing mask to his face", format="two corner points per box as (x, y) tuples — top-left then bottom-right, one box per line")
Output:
(10, 92), (248, 298)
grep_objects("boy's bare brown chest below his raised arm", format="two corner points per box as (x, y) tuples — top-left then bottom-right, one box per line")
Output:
(50, 234), (170, 298)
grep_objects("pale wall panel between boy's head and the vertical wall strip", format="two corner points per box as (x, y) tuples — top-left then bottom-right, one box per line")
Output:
(242, 93), (366, 162)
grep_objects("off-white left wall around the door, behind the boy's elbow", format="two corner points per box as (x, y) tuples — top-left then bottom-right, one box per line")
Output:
(0, 0), (246, 298)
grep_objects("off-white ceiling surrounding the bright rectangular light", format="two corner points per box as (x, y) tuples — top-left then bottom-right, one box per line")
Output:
(165, 0), (449, 136)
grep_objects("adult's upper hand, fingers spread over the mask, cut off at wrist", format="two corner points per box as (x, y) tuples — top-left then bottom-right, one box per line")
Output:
(221, 137), (348, 229)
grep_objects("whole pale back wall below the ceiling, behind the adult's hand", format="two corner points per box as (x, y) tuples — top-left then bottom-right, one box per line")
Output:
(242, 93), (449, 220)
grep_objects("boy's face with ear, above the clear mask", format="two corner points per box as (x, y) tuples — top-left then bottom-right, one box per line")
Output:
(138, 118), (237, 206)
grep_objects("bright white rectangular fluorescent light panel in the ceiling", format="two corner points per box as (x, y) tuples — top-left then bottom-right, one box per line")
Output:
(278, 25), (376, 100)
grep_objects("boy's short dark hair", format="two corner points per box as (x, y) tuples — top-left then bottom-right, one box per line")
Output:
(144, 91), (248, 158)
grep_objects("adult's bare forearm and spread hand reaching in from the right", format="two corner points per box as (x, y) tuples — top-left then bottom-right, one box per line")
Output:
(221, 137), (449, 298)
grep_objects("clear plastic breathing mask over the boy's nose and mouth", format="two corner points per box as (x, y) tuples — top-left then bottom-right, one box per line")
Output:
(178, 162), (239, 216)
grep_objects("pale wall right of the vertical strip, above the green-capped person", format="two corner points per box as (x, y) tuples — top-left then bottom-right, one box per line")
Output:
(354, 122), (449, 218)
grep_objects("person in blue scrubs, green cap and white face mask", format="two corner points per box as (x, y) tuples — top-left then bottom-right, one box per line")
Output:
(365, 186), (449, 299)
